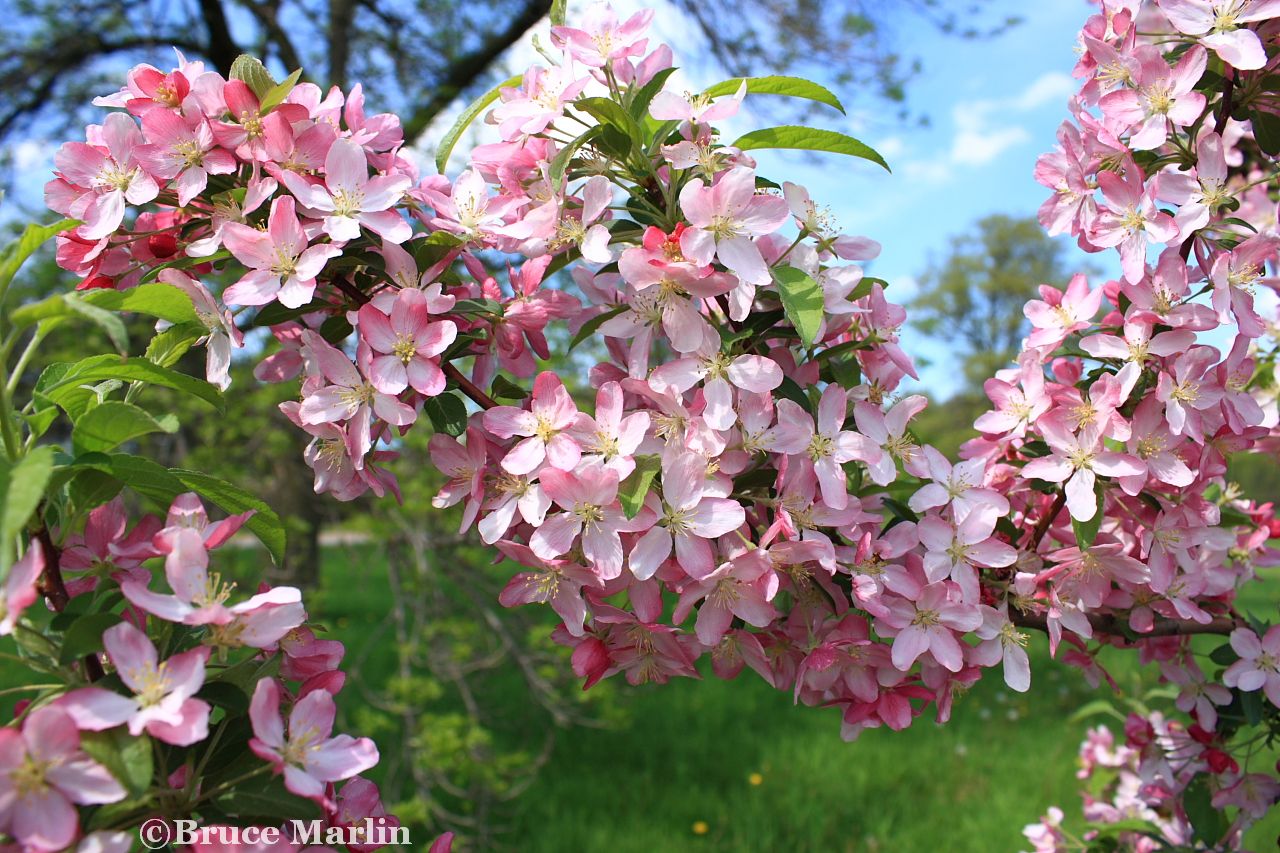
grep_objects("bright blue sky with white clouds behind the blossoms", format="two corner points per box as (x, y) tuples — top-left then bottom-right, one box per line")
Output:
(6, 0), (1111, 396)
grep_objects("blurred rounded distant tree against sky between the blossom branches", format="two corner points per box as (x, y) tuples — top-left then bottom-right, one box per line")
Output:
(908, 214), (1092, 391)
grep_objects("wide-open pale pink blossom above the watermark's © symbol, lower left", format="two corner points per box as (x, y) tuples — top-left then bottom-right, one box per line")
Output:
(58, 622), (210, 747)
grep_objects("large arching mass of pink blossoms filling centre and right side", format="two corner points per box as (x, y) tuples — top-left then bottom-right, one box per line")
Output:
(24, 0), (1280, 841)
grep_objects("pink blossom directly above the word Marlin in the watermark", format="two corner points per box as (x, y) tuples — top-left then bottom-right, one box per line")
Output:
(248, 679), (378, 803)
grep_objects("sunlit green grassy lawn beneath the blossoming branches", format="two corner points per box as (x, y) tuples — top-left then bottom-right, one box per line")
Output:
(314, 550), (1280, 853)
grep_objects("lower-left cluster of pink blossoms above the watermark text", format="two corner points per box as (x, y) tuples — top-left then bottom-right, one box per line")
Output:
(0, 493), (409, 853)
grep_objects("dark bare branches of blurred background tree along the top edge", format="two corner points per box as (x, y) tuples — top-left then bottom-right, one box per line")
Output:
(0, 0), (1015, 172)
